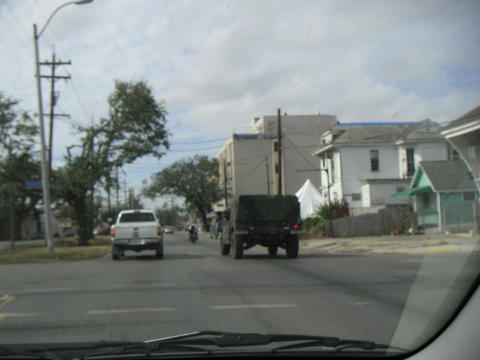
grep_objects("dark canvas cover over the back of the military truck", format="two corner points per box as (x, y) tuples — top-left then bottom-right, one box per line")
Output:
(235, 195), (300, 223)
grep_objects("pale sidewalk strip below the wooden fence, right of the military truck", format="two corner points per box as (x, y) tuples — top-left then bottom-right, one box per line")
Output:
(300, 234), (480, 255)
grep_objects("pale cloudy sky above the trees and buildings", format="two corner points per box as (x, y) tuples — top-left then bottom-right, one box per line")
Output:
(0, 0), (480, 206)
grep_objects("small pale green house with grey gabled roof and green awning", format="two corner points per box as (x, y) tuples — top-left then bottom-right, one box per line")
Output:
(393, 160), (479, 232)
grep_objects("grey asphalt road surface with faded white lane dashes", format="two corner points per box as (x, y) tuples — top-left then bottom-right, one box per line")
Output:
(0, 233), (472, 343)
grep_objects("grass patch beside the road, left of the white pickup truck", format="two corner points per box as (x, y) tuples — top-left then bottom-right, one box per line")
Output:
(0, 237), (111, 264)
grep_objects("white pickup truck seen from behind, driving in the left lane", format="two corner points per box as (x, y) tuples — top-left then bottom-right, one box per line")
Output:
(111, 210), (163, 260)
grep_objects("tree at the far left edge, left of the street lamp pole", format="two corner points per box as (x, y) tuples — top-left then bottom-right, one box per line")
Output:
(0, 93), (41, 248)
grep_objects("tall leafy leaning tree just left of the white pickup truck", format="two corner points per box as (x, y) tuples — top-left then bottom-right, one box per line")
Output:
(56, 81), (169, 245)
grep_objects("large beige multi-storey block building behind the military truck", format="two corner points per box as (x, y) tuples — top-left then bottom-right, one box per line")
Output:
(214, 114), (337, 212)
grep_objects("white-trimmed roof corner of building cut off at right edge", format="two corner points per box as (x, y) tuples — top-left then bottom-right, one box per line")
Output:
(442, 106), (480, 190)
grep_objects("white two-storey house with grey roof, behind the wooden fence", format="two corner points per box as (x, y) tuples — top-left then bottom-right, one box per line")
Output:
(314, 119), (452, 214)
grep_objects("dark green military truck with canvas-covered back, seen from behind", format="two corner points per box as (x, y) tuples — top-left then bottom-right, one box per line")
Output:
(220, 195), (301, 259)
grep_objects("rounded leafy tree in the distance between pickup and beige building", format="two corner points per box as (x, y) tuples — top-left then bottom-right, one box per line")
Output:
(143, 155), (221, 231)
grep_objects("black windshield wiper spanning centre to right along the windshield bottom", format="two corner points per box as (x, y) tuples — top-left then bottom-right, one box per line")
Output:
(85, 331), (407, 358)
